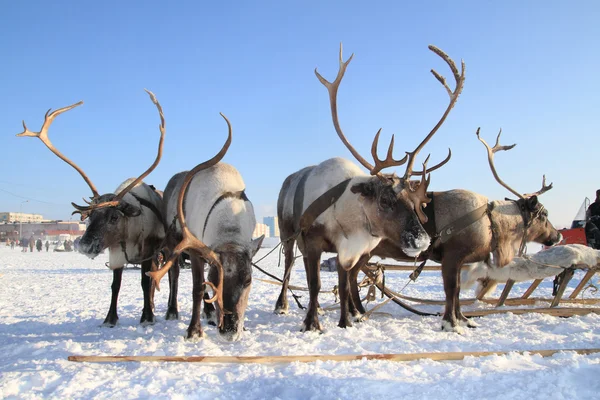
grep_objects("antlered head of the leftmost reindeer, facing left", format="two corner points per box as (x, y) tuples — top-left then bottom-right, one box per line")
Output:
(17, 90), (165, 258)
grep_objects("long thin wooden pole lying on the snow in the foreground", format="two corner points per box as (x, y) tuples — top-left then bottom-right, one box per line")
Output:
(69, 348), (600, 364)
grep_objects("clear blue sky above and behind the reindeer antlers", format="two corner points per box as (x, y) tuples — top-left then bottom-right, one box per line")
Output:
(0, 0), (600, 227)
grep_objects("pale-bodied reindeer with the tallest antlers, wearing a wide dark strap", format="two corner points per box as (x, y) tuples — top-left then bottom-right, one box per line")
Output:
(275, 45), (464, 331)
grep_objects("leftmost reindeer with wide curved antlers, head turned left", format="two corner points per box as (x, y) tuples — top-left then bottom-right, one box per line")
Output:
(17, 90), (165, 327)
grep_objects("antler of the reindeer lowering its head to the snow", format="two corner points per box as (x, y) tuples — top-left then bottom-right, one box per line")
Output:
(146, 114), (232, 326)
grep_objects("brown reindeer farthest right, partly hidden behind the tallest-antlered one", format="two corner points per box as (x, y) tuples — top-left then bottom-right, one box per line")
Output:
(349, 129), (562, 333)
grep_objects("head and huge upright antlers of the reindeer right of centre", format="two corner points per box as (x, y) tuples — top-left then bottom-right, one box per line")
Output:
(315, 45), (465, 255)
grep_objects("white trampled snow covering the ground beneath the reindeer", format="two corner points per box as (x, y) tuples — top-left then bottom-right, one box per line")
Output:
(0, 246), (600, 400)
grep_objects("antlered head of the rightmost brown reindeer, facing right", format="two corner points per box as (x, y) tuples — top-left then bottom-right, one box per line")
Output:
(476, 128), (562, 246)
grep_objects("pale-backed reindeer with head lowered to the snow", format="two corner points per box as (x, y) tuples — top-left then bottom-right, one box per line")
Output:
(148, 114), (264, 341)
